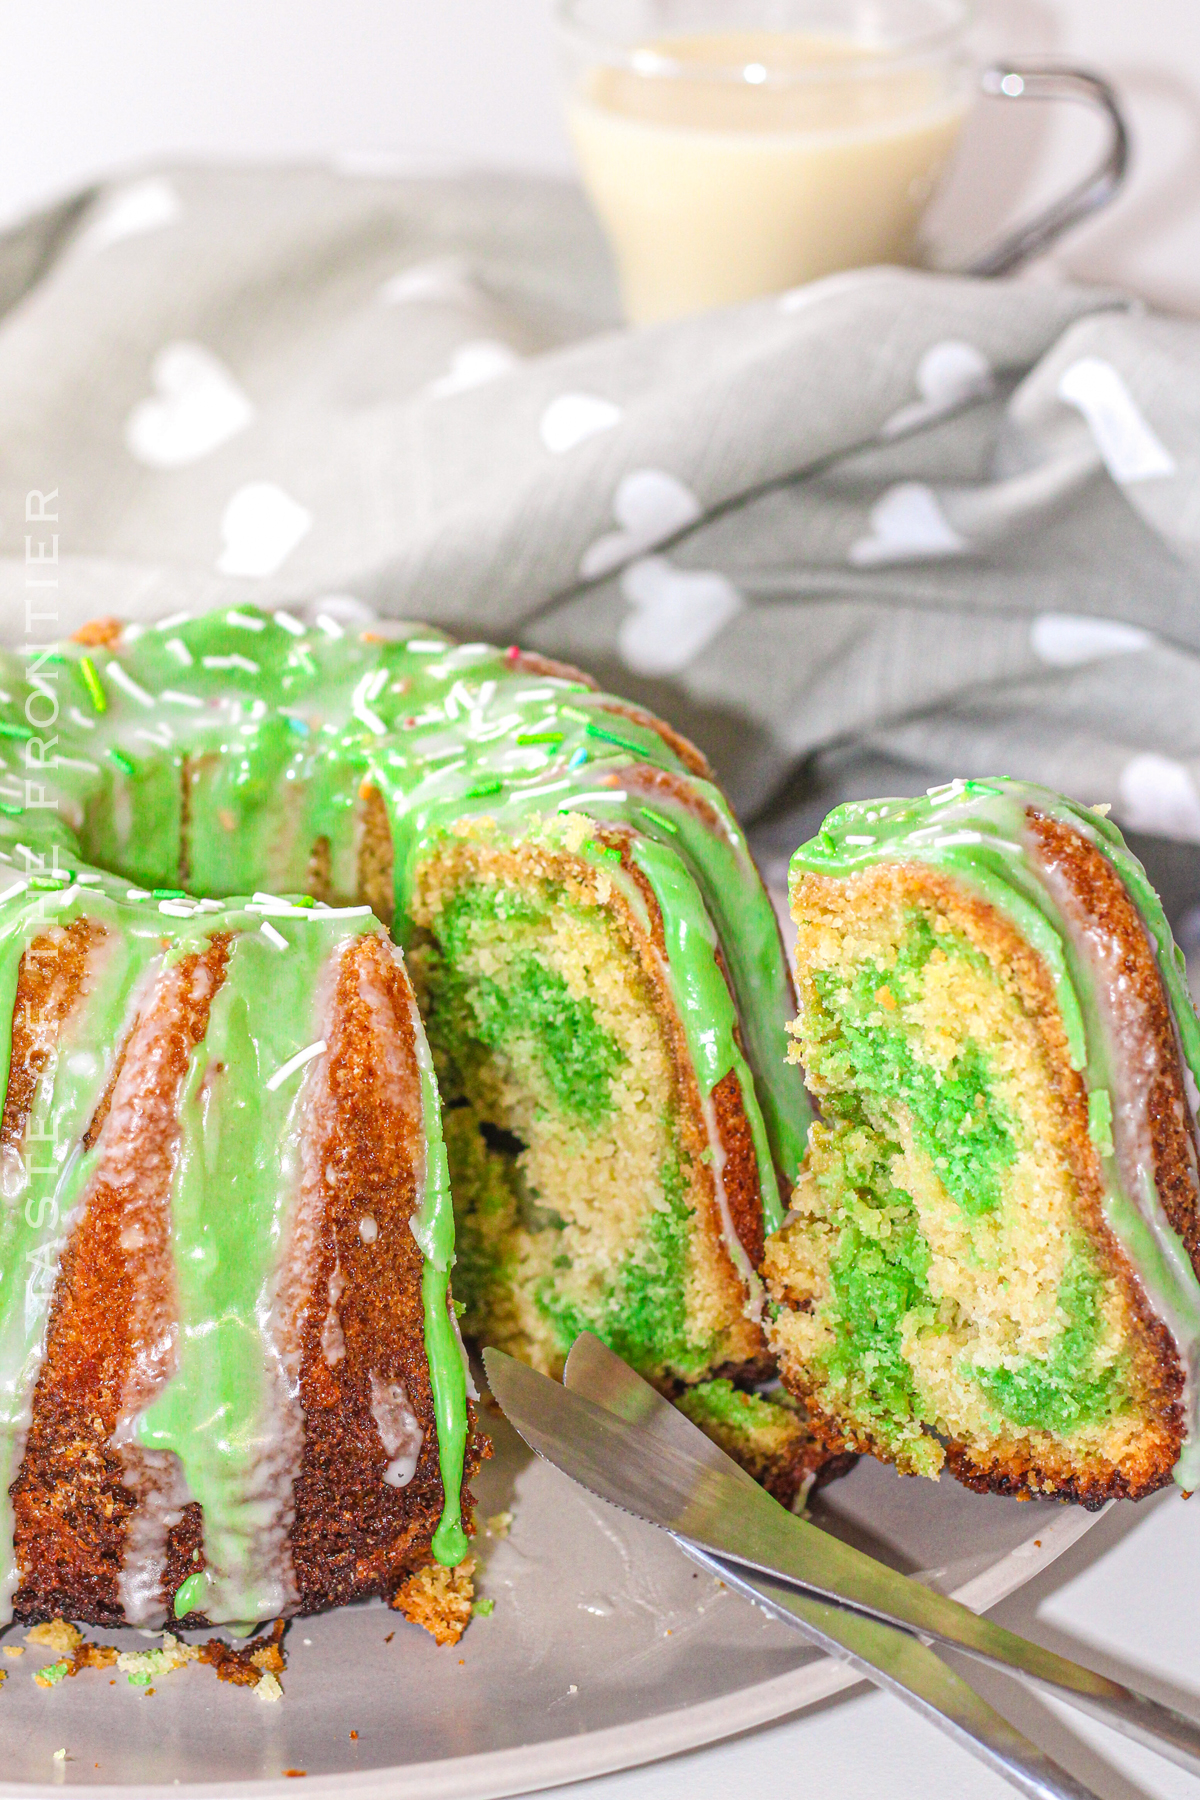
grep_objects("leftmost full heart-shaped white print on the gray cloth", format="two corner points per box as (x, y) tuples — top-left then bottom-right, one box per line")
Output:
(124, 342), (254, 468)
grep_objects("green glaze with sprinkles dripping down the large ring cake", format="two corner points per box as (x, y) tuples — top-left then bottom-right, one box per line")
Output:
(0, 607), (808, 1616)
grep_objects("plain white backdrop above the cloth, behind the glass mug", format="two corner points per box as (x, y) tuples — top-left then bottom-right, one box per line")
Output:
(0, 0), (1200, 313)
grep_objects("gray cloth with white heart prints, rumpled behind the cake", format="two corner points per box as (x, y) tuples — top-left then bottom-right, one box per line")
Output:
(0, 169), (1200, 921)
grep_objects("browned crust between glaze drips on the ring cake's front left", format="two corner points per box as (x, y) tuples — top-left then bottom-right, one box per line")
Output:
(4, 922), (489, 1625)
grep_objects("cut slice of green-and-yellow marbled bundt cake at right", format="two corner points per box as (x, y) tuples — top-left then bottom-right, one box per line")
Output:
(765, 779), (1200, 1507)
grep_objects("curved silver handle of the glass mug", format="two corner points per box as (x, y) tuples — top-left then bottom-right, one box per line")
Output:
(961, 63), (1130, 275)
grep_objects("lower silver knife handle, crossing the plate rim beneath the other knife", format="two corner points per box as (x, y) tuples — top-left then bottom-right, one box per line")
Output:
(671, 1534), (1096, 1800)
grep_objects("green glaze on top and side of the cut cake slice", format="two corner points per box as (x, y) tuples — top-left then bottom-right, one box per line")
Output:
(792, 778), (1200, 1490)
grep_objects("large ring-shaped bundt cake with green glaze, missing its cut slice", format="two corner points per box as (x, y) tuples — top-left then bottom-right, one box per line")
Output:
(0, 607), (808, 1624)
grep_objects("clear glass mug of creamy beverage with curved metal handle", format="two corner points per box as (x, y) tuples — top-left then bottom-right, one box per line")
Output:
(558, 0), (1128, 324)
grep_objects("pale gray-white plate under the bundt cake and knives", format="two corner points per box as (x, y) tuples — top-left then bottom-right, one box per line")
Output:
(0, 1413), (1097, 1800)
